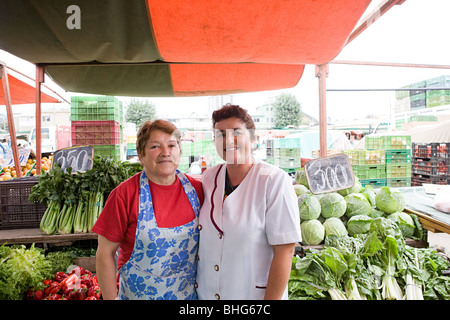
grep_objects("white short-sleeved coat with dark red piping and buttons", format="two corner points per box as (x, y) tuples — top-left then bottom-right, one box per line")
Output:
(196, 161), (301, 300)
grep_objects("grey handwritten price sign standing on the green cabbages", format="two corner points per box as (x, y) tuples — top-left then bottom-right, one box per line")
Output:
(305, 153), (355, 194)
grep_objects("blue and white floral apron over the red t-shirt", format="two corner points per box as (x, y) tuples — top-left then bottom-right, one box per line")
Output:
(118, 170), (200, 300)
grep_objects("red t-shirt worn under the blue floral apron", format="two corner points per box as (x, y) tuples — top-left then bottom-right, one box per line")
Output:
(92, 173), (203, 268)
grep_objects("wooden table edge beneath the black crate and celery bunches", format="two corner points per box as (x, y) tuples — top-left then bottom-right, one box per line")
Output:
(0, 228), (97, 245)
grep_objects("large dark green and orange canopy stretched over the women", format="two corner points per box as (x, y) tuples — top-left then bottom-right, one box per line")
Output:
(0, 0), (370, 96)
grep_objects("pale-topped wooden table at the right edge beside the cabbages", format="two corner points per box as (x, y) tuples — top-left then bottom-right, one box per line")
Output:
(395, 187), (450, 234)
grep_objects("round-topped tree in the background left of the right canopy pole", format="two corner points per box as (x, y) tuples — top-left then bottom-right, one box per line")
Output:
(272, 93), (302, 128)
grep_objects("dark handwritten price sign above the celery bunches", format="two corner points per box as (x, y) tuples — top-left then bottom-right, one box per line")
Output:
(52, 146), (94, 173)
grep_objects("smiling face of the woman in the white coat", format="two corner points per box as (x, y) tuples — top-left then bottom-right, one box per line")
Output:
(214, 117), (252, 164)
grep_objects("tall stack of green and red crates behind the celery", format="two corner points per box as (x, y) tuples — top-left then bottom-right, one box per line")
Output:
(70, 96), (123, 160)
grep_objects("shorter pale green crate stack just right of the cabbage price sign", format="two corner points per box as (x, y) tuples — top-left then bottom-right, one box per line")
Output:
(343, 149), (386, 189)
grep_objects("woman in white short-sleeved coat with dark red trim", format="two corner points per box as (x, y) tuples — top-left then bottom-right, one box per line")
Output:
(196, 104), (301, 300)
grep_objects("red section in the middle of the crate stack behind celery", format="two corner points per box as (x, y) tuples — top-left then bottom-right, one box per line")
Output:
(72, 120), (120, 146)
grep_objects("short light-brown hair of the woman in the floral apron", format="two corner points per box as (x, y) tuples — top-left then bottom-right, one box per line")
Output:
(136, 119), (181, 156)
